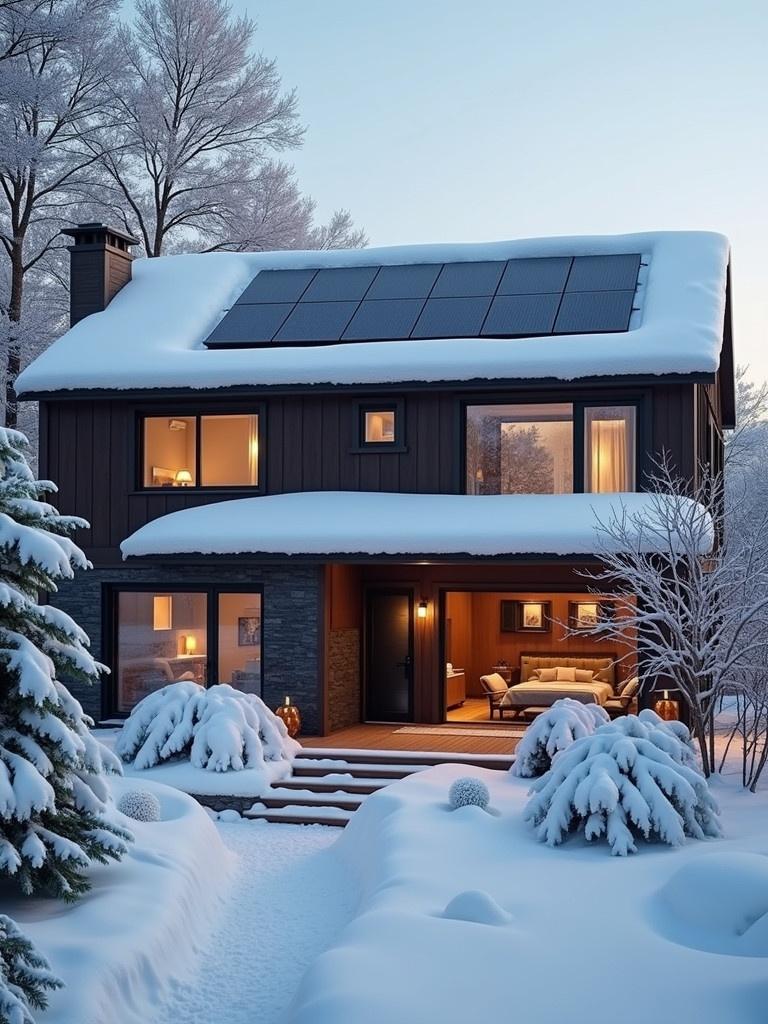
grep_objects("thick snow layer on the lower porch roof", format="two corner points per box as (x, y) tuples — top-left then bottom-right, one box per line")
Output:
(120, 490), (716, 558)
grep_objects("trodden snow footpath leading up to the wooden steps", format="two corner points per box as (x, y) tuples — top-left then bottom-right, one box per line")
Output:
(153, 821), (358, 1024)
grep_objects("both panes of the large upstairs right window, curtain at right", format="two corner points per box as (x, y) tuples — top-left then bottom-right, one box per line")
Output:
(466, 402), (637, 495)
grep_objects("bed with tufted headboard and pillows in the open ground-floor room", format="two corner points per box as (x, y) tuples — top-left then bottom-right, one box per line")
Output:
(498, 653), (616, 718)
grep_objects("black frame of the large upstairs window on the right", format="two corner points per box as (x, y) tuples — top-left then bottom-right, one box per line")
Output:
(456, 388), (650, 497)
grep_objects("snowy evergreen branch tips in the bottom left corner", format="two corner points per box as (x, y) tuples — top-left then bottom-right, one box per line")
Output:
(0, 913), (62, 1024)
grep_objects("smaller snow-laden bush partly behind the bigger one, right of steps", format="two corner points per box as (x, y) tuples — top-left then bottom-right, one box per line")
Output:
(510, 697), (610, 778)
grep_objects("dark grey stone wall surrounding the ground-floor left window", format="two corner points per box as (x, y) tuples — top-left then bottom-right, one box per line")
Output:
(50, 563), (323, 733)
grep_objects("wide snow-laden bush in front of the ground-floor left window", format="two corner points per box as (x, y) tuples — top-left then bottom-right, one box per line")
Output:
(115, 682), (299, 771)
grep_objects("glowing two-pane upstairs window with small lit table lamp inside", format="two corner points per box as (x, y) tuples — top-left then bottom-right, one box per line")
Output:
(142, 413), (259, 487)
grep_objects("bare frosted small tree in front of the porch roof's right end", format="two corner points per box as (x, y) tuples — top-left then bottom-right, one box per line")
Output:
(580, 460), (768, 775)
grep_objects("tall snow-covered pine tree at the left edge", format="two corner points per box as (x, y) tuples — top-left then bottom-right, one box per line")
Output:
(0, 428), (131, 899)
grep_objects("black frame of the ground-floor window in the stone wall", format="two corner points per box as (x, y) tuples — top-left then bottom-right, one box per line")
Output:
(101, 580), (267, 719)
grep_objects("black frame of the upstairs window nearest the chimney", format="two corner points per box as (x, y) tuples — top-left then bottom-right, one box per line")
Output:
(134, 402), (266, 496)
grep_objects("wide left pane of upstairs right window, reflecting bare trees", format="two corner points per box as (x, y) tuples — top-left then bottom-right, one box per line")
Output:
(467, 402), (573, 495)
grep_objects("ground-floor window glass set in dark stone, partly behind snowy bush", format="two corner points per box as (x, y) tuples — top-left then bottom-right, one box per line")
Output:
(114, 589), (262, 713)
